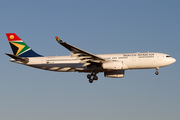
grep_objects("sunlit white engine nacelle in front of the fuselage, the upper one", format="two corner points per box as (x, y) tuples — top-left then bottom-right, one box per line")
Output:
(102, 61), (123, 70)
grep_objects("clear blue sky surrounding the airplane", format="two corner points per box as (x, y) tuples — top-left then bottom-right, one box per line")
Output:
(0, 0), (180, 120)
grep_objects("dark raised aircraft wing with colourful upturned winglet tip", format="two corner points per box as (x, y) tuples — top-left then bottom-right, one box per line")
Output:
(55, 37), (106, 66)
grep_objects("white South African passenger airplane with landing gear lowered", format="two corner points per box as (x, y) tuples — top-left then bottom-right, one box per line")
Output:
(5, 33), (176, 83)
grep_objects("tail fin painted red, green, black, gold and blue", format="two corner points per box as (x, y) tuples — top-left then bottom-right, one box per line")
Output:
(6, 33), (42, 57)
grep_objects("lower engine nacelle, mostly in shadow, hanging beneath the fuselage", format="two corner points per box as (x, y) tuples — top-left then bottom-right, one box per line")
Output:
(104, 70), (124, 78)
